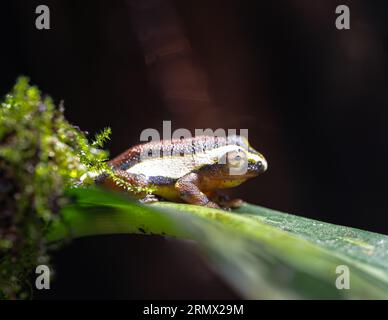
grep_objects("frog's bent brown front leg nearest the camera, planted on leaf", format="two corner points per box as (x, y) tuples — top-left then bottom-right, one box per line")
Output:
(175, 172), (219, 208)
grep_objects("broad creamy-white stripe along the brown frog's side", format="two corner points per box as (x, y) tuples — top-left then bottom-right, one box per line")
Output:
(127, 145), (243, 179)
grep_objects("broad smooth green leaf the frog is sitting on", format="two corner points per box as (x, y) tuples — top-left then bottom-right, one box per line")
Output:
(49, 189), (388, 299)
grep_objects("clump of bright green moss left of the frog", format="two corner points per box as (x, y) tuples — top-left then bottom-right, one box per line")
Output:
(0, 77), (123, 298)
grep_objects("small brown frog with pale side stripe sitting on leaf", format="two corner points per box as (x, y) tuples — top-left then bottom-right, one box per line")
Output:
(96, 135), (268, 209)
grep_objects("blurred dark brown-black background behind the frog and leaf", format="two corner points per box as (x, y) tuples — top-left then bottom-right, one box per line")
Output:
(0, 0), (388, 299)
